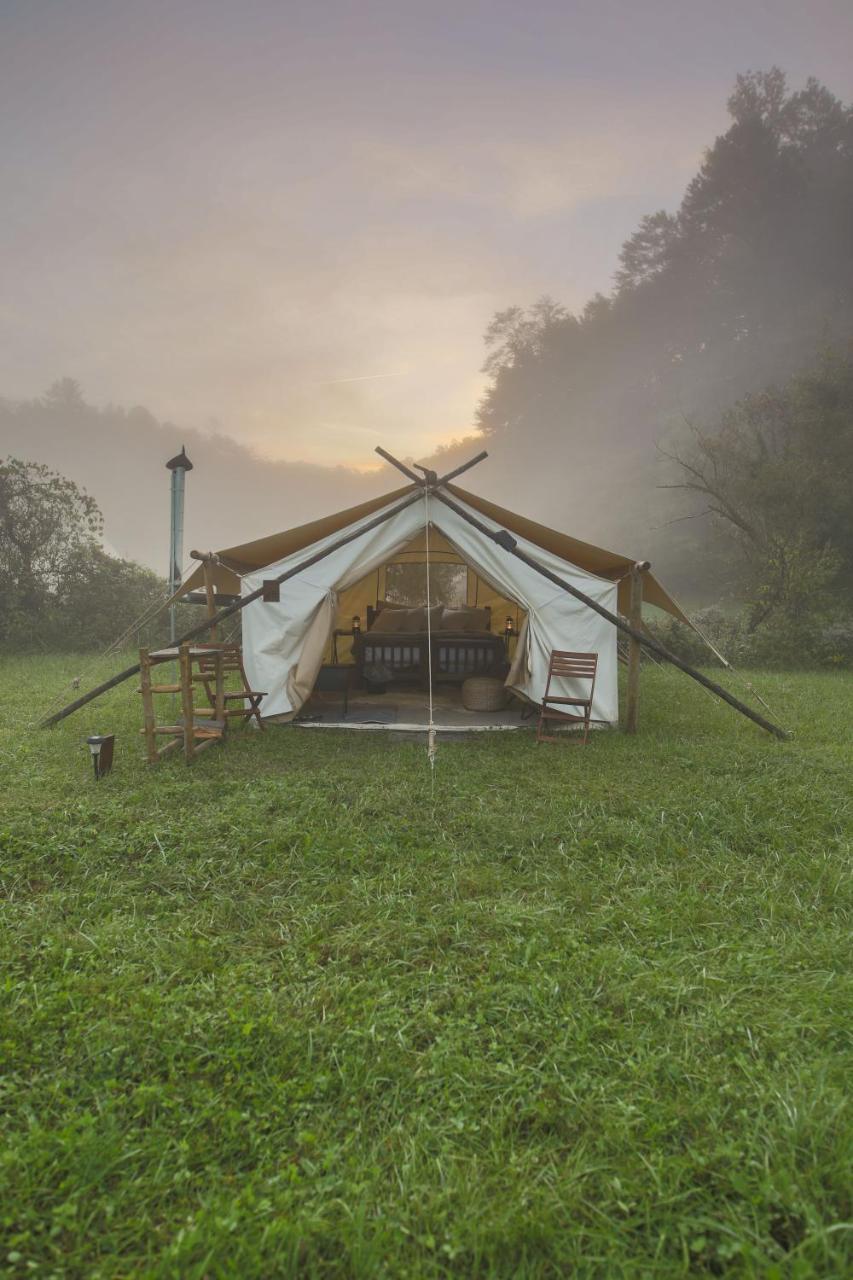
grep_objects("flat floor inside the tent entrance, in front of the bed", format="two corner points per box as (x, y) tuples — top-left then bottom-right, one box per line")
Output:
(291, 685), (535, 733)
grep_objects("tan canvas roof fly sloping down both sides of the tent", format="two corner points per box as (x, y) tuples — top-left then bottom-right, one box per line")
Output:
(179, 484), (690, 625)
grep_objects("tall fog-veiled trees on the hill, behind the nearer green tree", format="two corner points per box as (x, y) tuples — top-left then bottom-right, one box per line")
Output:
(478, 69), (853, 594)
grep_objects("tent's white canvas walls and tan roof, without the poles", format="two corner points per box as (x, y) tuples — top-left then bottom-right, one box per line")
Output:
(174, 484), (688, 723)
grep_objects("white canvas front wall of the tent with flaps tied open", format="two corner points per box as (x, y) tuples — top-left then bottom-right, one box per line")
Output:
(241, 494), (619, 723)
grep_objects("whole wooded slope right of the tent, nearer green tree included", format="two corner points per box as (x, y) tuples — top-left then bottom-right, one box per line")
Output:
(479, 69), (853, 660)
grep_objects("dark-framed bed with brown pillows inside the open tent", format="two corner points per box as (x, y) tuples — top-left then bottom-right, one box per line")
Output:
(352, 602), (507, 686)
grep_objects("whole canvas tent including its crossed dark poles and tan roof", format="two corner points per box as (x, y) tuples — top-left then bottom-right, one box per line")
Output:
(40, 458), (790, 742)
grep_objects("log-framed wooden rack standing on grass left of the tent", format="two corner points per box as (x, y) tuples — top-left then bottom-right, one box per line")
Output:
(138, 644), (227, 764)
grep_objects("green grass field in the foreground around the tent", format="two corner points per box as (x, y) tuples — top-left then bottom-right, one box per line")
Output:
(0, 658), (853, 1277)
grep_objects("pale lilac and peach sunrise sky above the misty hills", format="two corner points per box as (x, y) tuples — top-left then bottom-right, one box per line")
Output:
(0, 0), (853, 466)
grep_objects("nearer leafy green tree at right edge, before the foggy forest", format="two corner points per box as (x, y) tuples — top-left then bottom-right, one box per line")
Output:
(666, 352), (853, 630)
